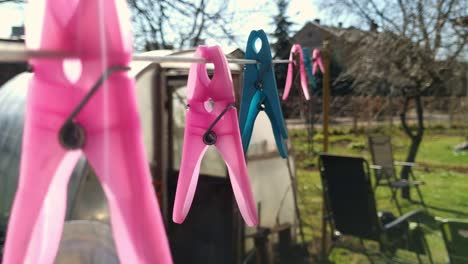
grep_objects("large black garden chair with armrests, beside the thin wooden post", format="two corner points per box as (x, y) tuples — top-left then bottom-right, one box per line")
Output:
(319, 154), (432, 263)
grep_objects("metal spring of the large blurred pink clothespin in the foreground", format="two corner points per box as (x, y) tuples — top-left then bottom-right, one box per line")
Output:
(59, 66), (130, 150)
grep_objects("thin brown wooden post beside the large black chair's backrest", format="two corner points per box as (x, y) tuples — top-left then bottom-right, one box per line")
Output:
(321, 40), (330, 259)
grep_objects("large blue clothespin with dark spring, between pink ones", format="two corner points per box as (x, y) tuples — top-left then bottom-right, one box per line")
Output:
(239, 30), (288, 158)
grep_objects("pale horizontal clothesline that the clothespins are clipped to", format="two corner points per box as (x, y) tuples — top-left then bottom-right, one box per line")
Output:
(0, 49), (293, 64)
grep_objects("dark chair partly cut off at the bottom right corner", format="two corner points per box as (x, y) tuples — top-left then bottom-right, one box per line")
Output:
(440, 219), (468, 264)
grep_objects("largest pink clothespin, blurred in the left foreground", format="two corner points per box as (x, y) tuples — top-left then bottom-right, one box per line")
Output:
(3, 0), (172, 264)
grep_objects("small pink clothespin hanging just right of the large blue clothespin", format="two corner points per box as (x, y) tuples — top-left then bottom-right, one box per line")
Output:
(283, 44), (310, 100)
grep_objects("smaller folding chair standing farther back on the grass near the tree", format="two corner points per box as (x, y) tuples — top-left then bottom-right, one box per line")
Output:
(368, 135), (426, 214)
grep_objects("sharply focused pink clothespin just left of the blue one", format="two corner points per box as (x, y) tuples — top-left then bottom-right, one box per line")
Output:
(172, 46), (258, 226)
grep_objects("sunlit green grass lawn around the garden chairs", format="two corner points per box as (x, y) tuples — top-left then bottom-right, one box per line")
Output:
(290, 128), (468, 263)
